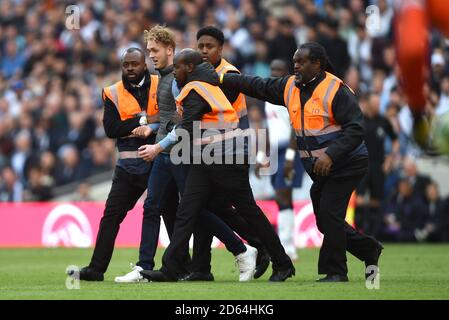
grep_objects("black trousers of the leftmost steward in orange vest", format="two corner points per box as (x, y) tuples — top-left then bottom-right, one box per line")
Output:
(89, 167), (149, 273)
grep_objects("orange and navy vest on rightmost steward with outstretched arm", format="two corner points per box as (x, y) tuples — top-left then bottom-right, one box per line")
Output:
(284, 72), (343, 158)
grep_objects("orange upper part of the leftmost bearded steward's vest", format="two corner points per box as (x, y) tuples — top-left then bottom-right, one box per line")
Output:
(103, 75), (159, 120)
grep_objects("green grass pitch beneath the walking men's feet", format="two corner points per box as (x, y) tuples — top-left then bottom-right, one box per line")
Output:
(0, 244), (449, 300)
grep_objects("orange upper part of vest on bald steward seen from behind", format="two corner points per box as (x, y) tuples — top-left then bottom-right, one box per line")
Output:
(175, 81), (239, 129)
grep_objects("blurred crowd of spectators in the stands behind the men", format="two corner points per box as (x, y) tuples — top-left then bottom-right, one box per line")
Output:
(0, 0), (449, 241)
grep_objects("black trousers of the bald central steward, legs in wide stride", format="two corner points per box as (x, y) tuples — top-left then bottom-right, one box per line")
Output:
(161, 164), (292, 278)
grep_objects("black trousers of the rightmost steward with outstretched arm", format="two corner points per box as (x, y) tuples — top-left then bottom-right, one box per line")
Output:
(310, 175), (378, 275)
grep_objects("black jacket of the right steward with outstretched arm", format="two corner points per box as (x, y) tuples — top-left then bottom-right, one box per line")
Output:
(222, 72), (368, 179)
